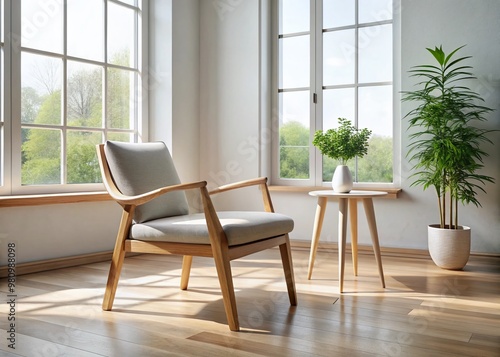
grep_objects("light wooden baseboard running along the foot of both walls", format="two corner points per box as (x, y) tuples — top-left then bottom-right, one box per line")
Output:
(0, 240), (500, 278)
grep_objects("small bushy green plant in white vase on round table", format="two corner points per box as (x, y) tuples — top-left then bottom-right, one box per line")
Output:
(312, 118), (372, 193)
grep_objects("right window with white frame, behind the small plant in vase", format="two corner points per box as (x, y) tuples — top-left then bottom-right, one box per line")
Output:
(273, 0), (395, 186)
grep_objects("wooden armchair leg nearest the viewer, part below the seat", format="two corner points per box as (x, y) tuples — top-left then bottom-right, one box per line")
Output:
(214, 249), (240, 331)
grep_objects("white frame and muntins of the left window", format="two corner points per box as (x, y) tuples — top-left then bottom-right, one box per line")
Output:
(0, 0), (149, 196)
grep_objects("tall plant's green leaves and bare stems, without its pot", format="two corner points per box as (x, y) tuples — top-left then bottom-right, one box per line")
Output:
(402, 46), (494, 229)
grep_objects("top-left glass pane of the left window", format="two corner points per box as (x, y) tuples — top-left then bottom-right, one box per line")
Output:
(21, 0), (63, 53)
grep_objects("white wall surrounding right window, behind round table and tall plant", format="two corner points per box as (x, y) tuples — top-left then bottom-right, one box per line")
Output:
(200, 0), (500, 253)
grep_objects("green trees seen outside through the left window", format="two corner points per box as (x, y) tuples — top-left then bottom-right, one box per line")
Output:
(21, 51), (131, 185)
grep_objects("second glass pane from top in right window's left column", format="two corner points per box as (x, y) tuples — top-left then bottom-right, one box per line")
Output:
(278, 36), (310, 88)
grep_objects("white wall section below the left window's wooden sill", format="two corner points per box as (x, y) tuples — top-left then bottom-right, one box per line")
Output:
(0, 201), (120, 266)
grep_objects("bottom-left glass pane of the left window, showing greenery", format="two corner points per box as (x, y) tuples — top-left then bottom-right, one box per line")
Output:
(21, 128), (61, 185)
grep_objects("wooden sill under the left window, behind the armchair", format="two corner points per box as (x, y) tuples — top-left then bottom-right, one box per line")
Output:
(0, 191), (111, 208)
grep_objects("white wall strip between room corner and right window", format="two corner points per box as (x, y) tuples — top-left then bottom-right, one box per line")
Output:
(200, 0), (270, 208)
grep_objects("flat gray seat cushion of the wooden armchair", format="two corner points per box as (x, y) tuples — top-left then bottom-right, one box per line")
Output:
(130, 211), (293, 246)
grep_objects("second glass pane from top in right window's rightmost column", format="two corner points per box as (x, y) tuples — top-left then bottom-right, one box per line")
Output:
(358, 25), (392, 83)
